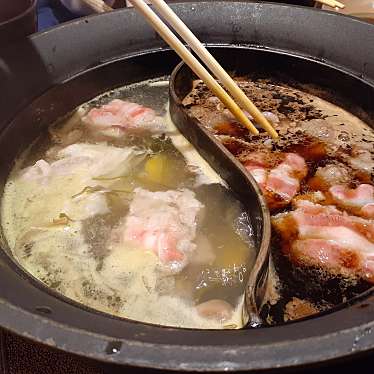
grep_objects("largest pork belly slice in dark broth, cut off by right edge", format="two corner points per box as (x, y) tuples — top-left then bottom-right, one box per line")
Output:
(272, 200), (374, 283)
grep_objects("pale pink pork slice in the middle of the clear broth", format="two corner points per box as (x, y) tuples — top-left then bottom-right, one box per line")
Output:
(112, 188), (203, 273)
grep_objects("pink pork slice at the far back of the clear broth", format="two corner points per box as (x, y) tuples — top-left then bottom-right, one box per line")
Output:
(82, 99), (163, 137)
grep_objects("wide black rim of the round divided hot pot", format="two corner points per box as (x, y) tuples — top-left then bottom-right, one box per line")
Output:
(0, 2), (374, 371)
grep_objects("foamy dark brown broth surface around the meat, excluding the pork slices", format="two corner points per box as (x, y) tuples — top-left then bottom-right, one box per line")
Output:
(183, 77), (374, 324)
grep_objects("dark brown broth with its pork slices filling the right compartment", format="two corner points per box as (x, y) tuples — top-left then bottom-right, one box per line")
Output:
(183, 77), (374, 324)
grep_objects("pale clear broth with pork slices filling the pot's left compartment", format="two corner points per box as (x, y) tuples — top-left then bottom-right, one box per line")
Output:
(1, 82), (256, 329)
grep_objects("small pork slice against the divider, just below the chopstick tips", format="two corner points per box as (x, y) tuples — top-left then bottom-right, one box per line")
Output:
(244, 152), (308, 210)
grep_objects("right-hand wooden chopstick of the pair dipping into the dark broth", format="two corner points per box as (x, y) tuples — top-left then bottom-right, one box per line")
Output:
(151, 0), (278, 139)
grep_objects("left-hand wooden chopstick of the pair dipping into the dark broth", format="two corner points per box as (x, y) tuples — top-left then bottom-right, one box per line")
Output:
(130, 0), (258, 135)
